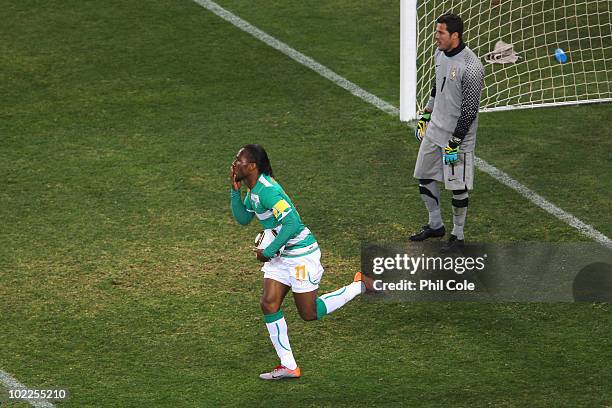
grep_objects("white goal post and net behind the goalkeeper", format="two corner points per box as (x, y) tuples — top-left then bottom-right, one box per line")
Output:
(400, 0), (612, 121)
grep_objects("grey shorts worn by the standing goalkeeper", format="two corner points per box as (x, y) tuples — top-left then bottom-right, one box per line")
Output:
(414, 137), (474, 190)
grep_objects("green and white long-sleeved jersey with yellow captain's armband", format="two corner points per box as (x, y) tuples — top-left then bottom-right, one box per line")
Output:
(231, 174), (319, 258)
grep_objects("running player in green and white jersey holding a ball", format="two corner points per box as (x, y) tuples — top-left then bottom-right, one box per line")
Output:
(230, 144), (373, 380)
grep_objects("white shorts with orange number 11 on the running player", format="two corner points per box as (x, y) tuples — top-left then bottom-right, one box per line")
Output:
(261, 250), (323, 293)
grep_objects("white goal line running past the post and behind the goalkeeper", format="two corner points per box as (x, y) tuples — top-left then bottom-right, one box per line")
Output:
(194, 0), (612, 250)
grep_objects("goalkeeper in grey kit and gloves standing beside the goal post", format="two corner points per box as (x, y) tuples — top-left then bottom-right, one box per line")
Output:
(410, 14), (484, 251)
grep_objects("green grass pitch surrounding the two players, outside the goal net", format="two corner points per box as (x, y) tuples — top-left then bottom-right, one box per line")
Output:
(0, 0), (612, 407)
